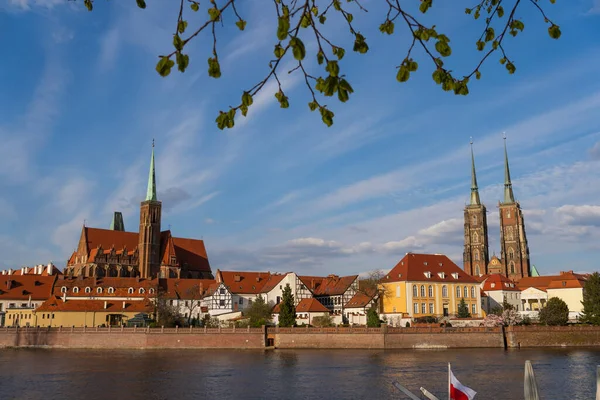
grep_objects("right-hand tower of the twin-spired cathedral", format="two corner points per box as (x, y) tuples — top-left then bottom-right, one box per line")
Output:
(498, 136), (531, 281)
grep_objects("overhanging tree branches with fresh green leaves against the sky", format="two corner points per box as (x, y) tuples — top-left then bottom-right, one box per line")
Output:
(75, 0), (561, 129)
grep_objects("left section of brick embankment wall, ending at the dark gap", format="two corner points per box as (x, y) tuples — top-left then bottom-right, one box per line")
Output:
(0, 328), (265, 349)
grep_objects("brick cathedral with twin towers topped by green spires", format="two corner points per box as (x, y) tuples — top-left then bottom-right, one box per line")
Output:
(463, 137), (531, 281)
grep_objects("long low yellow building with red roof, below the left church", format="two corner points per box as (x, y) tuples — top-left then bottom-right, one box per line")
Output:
(27, 296), (154, 327)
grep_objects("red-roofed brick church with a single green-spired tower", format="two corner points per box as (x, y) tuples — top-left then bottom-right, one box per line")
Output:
(64, 143), (214, 279)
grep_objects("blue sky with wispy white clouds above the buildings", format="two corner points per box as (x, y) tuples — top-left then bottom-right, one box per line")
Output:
(0, 0), (600, 275)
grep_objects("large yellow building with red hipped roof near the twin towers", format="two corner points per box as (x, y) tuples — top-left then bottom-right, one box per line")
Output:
(381, 253), (482, 318)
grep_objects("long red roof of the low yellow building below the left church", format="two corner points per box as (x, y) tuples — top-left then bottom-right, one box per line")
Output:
(35, 296), (154, 313)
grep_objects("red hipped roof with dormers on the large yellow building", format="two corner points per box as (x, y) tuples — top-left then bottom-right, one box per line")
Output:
(381, 253), (478, 283)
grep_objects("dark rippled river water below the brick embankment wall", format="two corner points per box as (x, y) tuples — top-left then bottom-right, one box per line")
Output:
(0, 349), (600, 400)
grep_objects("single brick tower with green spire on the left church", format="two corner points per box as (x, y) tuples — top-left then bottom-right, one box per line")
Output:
(138, 141), (162, 278)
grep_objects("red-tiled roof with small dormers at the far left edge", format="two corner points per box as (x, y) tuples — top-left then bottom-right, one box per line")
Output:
(0, 275), (56, 300)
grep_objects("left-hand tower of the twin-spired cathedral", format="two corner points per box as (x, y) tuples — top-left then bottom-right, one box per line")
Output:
(463, 141), (489, 276)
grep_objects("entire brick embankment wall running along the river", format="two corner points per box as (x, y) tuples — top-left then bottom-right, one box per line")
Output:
(0, 325), (600, 349)
